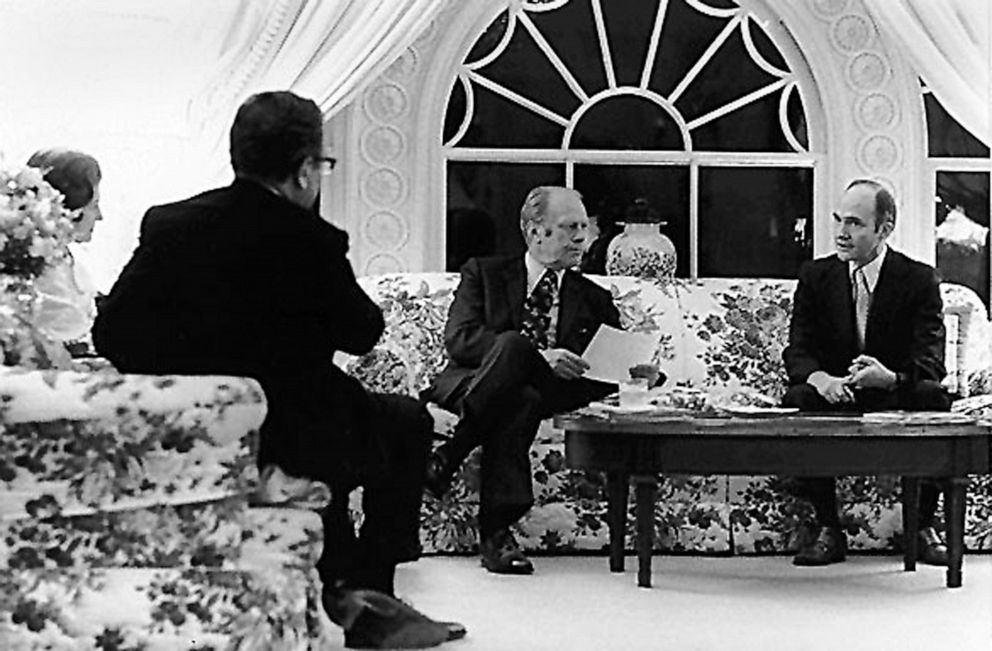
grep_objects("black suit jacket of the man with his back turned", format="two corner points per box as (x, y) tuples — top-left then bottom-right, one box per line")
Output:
(93, 179), (384, 475)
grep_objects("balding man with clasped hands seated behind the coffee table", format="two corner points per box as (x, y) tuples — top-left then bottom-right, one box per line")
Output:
(783, 179), (950, 565)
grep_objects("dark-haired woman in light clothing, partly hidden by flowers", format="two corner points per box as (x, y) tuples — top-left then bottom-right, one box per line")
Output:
(28, 149), (103, 342)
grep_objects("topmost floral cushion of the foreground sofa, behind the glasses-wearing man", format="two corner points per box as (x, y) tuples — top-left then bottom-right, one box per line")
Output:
(0, 368), (265, 520)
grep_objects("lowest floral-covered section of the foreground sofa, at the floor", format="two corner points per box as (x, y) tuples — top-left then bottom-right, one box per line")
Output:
(0, 568), (330, 651)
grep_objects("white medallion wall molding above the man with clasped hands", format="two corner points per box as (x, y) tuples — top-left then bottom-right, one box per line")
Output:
(767, 0), (934, 262)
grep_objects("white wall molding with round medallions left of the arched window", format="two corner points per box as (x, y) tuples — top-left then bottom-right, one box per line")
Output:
(327, 0), (464, 274)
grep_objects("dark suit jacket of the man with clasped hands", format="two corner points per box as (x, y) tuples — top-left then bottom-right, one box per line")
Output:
(783, 248), (946, 384)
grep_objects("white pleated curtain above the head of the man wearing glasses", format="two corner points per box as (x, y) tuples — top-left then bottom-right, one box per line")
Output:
(190, 0), (447, 185)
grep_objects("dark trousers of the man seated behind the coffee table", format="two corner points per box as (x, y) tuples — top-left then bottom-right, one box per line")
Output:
(782, 380), (951, 529)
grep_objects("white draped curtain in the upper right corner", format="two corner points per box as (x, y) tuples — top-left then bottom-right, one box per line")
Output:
(864, 0), (992, 145)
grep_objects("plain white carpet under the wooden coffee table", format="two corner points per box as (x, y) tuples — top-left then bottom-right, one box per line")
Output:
(330, 556), (992, 651)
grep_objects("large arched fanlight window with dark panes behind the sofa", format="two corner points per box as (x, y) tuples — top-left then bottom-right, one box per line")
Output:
(442, 0), (817, 277)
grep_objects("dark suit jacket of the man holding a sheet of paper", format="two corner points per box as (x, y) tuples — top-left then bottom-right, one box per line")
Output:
(431, 255), (620, 405)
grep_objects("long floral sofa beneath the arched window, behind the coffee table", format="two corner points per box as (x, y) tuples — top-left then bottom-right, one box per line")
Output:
(338, 273), (992, 554)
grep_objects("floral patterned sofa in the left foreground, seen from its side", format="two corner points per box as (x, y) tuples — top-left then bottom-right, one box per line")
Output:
(0, 367), (330, 650)
